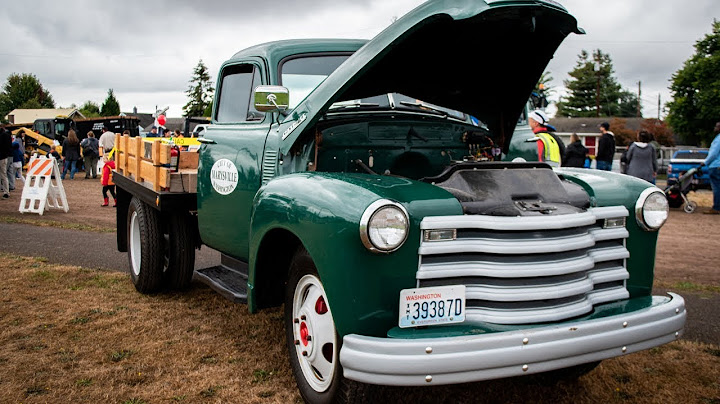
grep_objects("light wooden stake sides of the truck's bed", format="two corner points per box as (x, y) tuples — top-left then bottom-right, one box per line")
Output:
(114, 134), (199, 193)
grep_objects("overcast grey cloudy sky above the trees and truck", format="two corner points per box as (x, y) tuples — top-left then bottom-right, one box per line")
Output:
(0, 0), (720, 117)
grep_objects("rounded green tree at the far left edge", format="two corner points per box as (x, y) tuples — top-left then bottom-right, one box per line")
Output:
(0, 73), (55, 119)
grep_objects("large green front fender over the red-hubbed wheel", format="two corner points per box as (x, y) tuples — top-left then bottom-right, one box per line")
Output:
(248, 172), (462, 336)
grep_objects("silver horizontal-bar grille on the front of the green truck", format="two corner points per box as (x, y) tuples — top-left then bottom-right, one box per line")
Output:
(417, 206), (630, 324)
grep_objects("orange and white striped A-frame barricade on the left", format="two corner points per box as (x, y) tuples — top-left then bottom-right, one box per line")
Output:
(20, 154), (70, 215)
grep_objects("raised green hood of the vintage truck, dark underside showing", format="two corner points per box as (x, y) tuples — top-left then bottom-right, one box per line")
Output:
(279, 0), (584, 154)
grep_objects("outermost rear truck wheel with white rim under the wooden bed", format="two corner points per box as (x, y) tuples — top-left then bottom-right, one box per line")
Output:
(127, 198), (163, 293)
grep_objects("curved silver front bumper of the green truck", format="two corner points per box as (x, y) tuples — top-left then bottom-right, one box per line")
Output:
(340, 293), (686, 386)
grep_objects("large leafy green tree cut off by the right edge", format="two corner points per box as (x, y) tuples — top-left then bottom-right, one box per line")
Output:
(667, 20), (720, 144)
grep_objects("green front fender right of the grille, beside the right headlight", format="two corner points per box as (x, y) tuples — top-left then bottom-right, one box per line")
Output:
(556, 168), (659, 297)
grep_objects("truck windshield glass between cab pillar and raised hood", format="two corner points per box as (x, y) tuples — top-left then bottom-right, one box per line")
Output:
(280, 54), (350, 109)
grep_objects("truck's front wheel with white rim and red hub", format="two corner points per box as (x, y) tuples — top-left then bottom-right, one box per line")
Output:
(285, 249), (369, 403)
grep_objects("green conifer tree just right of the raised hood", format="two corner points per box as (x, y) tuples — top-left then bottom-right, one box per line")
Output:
(557, 49), (638, 117)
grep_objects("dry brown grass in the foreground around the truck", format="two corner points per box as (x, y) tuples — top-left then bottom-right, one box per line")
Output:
(0, 254), (720, 404)
